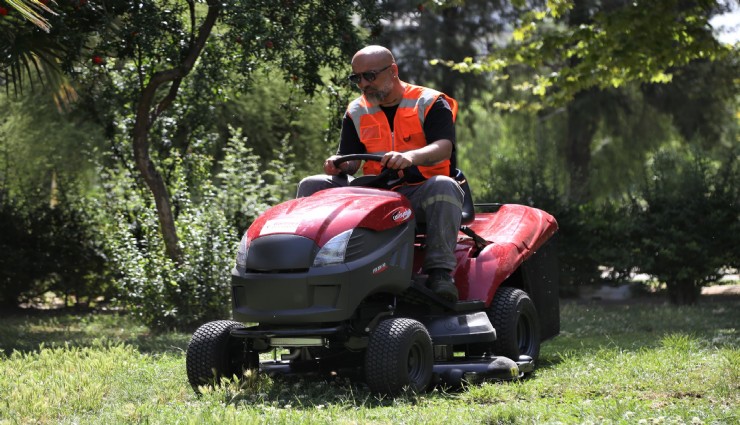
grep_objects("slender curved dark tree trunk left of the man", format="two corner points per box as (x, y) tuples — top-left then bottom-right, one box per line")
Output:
(133, 0), (221, 263)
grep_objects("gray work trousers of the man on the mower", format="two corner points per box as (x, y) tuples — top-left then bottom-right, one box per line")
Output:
(296, 174), (463, 271)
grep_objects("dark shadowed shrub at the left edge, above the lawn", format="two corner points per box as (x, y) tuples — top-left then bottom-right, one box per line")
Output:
(0, 190), (110, 308)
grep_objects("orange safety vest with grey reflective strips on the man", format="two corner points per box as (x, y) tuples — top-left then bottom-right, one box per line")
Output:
(347, 83), (457, 179)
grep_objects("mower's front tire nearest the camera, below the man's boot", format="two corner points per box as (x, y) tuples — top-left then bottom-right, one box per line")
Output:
(365, 317), (434, 396)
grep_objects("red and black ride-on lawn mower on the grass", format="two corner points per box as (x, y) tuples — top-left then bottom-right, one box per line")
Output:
(186, 155), (560, 395)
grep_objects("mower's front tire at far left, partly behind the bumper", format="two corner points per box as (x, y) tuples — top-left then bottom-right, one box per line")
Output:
(185, 320), (259, 394)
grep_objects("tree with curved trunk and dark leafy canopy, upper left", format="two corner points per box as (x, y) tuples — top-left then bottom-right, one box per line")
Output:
(1, 0), (377, 261)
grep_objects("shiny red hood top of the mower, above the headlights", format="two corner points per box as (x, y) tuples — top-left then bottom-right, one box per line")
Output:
(247, 187), (413, 246)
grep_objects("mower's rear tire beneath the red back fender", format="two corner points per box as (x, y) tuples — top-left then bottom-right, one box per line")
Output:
(488, 287), (540, 361)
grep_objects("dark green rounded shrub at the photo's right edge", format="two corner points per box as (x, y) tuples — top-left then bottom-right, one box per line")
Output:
(633, 147), (740, 304)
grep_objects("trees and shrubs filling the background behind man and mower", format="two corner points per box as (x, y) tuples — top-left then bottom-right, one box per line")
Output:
(0, 0), (740, 329)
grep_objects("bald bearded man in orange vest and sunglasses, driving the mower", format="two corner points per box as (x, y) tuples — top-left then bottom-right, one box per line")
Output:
(297, 46), (463, 302)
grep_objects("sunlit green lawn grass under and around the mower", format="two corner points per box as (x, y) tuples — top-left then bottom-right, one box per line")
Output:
(0, 300), (740, 424)
